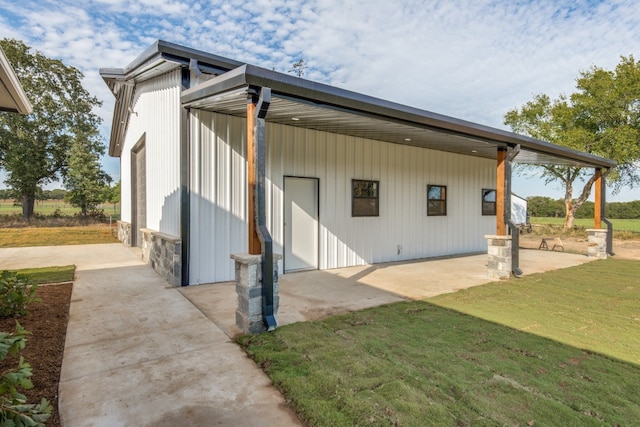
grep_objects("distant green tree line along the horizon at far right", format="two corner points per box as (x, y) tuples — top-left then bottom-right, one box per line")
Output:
(527, 196), (640, 219)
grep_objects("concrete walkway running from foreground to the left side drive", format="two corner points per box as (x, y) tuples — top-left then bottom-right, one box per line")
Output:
(0, 244), (301, 427)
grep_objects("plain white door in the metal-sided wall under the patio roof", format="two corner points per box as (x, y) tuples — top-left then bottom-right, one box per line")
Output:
(284, 177), (318, 273)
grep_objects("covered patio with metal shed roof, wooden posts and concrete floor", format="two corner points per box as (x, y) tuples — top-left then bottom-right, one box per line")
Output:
(181, 65), (615, 335)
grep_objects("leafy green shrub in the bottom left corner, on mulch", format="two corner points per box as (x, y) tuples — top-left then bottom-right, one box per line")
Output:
(0, 322), (53, 426)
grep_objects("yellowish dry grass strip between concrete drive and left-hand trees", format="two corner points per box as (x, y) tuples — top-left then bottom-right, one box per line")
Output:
(0, 225), (118, 248)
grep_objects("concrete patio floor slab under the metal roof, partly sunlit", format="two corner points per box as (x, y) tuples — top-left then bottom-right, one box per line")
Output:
(179, 249), (595, 337)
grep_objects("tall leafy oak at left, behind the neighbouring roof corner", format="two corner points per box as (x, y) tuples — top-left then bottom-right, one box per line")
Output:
(0, 39), (101, 220)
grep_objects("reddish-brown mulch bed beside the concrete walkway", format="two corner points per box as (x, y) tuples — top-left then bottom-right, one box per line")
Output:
(0, 283), (73, 426)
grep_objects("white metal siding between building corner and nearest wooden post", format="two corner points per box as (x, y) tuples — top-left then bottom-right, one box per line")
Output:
(190, 110), (247, 284)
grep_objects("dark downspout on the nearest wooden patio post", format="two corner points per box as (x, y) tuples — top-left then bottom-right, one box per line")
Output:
(254, 87), (278, 331)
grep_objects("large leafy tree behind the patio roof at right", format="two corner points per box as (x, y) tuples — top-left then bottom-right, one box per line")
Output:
(504, 56), (640, 229)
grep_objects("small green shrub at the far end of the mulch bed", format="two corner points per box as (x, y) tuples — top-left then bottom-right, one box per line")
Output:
(0, 270), (40, 317)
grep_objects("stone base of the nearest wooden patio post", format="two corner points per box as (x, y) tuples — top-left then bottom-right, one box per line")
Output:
(231, 254), (282, 334)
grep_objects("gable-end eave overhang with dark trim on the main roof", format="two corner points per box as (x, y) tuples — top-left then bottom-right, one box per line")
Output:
(100, 40), (242, 157)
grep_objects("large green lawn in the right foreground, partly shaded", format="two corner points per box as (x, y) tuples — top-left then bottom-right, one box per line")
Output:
(239, 260), (640, 426)
